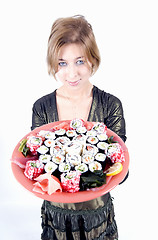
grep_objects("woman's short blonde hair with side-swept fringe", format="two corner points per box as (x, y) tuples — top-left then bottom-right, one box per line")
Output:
(47, 15), (100, 77)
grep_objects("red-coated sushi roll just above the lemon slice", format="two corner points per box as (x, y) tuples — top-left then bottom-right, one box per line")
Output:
(107, 143), (125, 163)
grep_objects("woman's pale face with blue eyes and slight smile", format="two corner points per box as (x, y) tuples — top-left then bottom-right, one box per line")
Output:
(56, 43), (92, 89)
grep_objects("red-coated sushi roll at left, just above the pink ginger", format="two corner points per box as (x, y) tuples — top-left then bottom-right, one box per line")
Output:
(24, 160), (44, 180)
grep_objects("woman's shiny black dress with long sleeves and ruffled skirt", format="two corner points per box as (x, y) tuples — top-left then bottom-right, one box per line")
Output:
(31, 86), (126, 240)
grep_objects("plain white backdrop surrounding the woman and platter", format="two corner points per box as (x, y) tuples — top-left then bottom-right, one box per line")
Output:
(0, 0), (158, 240)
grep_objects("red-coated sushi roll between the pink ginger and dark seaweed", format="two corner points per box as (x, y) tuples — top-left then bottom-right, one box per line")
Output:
(60, 171), (81, 193)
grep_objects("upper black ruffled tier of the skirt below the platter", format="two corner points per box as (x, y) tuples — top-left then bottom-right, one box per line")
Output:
(42, 197), (116, 232)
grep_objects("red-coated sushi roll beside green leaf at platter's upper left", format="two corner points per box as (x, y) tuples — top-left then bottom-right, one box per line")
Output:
(26, 136), (43, 155)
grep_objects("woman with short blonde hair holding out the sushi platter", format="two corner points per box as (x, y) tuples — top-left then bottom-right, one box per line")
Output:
(32, 16), (126, 240)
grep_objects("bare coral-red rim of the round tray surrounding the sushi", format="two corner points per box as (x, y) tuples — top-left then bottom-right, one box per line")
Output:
(11, 121), (129, 203)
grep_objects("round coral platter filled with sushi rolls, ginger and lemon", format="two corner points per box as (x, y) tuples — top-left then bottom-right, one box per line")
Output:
(11, 119), (129, 203)
